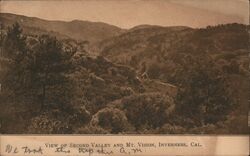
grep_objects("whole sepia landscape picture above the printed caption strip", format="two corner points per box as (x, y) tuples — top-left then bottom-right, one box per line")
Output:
(0, 0), (250, 135)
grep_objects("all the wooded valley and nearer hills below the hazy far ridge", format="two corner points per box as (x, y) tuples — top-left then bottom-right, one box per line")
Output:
(0, 16), (250, 134)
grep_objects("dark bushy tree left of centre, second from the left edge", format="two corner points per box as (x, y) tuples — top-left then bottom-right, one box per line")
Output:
(31, 35), (71, 110)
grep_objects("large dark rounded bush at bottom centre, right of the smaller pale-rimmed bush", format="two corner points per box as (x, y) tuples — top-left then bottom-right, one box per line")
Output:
(122, 93), (174, 130)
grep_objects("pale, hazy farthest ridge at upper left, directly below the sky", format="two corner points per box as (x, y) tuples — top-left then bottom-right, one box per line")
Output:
(0, 13), (124, 43)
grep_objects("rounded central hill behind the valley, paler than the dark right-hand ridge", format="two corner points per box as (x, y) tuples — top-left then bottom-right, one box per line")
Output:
(98, 25), (194, 67)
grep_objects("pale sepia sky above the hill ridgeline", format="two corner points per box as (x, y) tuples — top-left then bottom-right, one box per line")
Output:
(0, 0), (249, 28)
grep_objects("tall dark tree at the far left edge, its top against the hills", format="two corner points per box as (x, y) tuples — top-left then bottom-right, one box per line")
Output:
(1, 23), (28, 97)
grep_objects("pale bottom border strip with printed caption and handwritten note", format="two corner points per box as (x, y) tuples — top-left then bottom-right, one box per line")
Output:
(0, 135), (248, 156)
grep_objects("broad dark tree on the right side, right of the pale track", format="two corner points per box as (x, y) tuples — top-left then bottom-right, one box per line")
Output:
(176, 54), (233, 126)
